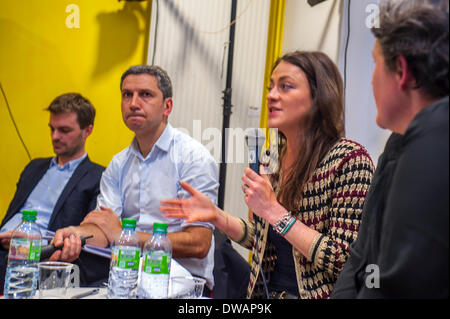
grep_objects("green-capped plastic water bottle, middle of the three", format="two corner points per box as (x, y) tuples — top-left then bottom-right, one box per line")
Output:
(108, 218), (141, 299)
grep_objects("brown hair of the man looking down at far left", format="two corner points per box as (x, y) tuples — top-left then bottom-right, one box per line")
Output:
(46, 93), (95, 129)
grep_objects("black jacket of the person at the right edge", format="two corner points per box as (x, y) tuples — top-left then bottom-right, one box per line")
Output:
(331, 96), (449, 299)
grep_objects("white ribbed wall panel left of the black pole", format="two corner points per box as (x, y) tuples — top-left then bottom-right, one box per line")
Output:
(149, 0), (230, 135)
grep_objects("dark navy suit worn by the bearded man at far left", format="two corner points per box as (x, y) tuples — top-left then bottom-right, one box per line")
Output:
(0, 156), (110, 290)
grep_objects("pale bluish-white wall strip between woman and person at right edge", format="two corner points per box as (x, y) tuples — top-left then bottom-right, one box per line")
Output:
(339, 0), (390, 165)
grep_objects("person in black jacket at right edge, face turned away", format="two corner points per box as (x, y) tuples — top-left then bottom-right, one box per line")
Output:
(332, 0), (449, 298)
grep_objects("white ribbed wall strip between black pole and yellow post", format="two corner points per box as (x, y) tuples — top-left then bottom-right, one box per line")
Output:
(225, 0), (270, 259)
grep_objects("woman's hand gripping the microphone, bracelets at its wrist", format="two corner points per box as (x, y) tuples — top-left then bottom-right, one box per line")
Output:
(242, 165), (284, 224)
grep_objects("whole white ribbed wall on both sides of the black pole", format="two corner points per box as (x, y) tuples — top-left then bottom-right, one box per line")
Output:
(148, 0), (270, 259)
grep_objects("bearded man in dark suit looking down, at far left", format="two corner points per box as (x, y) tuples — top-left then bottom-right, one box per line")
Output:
(0, 93), (109, 293)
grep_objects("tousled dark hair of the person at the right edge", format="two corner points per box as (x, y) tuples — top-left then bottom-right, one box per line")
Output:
(372, 0), (449, 98)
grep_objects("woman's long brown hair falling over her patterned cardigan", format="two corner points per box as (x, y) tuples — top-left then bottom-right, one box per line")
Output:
(273, 51), (345, 211)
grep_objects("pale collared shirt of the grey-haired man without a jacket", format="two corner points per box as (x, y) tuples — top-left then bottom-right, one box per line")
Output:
(97, 124), (219, 288)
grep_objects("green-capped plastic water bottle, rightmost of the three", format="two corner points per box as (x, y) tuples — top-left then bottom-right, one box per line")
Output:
(138, 223), (172, 299)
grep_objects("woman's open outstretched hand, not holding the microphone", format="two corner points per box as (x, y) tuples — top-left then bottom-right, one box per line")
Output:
(160, 182), (219, 224)
